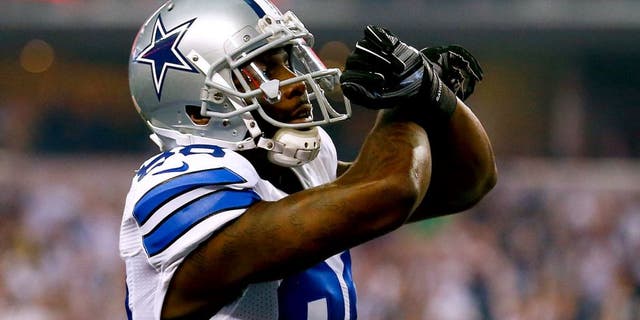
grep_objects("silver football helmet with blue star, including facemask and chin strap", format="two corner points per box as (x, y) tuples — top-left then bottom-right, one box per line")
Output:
(129, 0), (351, 166)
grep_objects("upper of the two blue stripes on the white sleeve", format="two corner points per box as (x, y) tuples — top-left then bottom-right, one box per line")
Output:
(133, 168), (246, 226)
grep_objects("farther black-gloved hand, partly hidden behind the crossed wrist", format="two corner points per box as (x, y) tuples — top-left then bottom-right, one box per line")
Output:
(421, 45), (483, 100)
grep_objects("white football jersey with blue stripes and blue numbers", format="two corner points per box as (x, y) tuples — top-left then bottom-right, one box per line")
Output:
(120, 128), (356, 320)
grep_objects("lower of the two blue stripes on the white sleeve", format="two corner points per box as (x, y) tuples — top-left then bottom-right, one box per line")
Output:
(142, 189), (260, 256)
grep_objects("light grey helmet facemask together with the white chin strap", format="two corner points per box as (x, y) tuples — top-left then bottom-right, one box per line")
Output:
(188, 12), (351, 167)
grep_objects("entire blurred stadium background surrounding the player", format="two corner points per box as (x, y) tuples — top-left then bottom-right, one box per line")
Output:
(0, 0), (640, 320)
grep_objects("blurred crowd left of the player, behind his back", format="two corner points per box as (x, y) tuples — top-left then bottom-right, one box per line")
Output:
(0, 154), (135, 320)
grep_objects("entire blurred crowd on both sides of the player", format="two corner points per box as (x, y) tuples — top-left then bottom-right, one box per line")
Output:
(0, 154), (640, 320)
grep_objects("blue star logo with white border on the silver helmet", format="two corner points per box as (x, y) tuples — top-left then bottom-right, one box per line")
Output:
(134, 16), (198, 100)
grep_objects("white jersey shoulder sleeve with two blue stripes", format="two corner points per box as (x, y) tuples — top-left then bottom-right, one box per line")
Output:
(128, 145), (260, 270)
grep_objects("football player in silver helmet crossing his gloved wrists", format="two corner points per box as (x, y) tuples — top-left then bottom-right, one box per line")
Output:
(120, 0), (496, 320)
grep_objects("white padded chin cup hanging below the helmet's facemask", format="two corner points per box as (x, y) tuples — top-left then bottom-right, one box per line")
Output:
(258, 127), (320, 167)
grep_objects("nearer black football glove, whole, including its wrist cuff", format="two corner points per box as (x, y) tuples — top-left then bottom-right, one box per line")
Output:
(340, 26), (456, 115)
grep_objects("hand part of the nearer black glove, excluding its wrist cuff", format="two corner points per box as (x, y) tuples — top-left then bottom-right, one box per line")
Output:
(340, 26), (424, 109)
